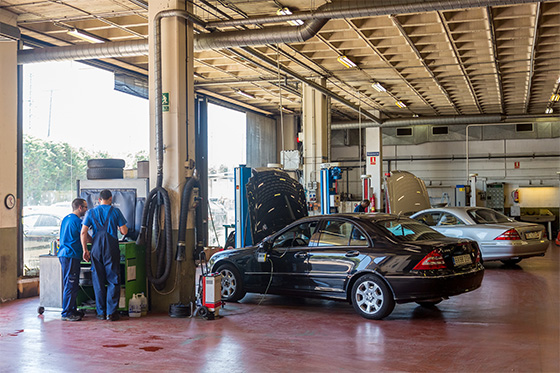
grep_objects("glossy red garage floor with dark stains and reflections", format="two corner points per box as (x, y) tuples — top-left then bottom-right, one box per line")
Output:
(0, 244), (560, 373)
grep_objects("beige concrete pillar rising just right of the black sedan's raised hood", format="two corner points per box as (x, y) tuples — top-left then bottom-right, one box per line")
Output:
(302, 79), (330, 211)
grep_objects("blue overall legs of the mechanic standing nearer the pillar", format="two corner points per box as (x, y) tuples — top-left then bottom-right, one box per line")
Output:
(91, 248), (121, 315)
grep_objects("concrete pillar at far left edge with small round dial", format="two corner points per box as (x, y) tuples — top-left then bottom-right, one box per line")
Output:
(0, 10), (19, 303)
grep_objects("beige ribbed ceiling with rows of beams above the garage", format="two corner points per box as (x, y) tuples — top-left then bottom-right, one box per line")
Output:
(5, 0), (560, 125)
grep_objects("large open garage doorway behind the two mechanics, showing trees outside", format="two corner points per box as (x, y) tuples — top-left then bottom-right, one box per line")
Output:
(22, 62), (149, 274)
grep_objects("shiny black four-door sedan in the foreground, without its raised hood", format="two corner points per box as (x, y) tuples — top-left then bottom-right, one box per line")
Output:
(209, 214), (484, 319)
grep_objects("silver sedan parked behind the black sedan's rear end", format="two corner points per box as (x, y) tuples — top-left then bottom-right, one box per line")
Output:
(411, 207), (549, 264)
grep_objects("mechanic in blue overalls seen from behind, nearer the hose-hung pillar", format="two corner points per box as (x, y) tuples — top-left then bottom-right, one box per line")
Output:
(81, 189), (128, 321)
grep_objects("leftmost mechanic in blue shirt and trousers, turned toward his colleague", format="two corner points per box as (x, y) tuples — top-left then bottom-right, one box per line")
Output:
(58, 198), (87, 321)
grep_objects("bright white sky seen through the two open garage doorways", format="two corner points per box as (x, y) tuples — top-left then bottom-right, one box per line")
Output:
(23, 62), (245, 170)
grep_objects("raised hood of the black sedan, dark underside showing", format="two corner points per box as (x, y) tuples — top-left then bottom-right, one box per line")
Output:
(246, 169), (307, 243)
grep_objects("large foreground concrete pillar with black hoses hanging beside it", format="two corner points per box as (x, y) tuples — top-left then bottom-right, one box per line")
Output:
(148, 0), (195, 312)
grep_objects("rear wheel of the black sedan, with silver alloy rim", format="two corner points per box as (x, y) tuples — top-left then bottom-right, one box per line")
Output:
(351, 275), (395, 320)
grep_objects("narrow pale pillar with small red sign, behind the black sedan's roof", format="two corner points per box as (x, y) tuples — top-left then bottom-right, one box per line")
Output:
(365, 127), (383, 211)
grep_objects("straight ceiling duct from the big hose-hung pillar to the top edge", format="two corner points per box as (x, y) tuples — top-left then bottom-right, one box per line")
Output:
(208, 0), (545, 27)
